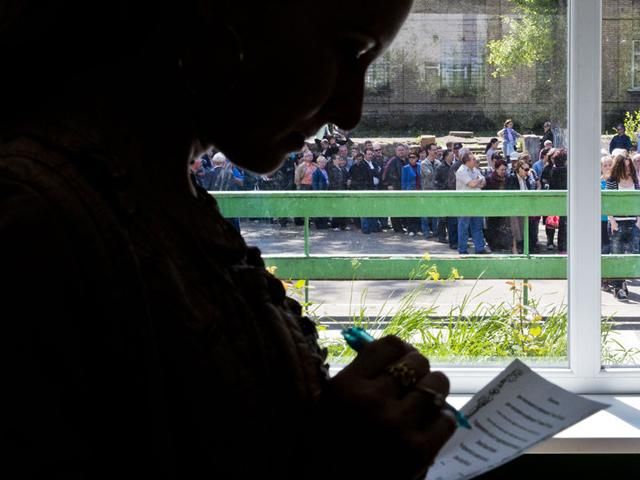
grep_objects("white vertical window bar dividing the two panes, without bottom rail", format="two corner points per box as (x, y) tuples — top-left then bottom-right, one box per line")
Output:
(568, 0), (602, 384)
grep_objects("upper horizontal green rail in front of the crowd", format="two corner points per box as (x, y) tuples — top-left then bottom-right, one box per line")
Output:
(210, 190), (640, 218)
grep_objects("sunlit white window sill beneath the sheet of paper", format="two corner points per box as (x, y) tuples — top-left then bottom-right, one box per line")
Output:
(447, 395), (640, 454)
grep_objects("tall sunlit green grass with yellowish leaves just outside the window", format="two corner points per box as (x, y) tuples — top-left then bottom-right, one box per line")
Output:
(272, 257), (640, 366)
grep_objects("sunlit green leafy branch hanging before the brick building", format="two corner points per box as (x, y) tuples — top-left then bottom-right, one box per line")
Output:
(487, 0), (559, 78)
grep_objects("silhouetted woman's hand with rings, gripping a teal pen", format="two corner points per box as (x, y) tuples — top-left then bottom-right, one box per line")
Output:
(321, 336), (456, 480)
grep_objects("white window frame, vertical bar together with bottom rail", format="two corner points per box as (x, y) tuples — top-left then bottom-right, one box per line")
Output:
(443, 0), (640, 394)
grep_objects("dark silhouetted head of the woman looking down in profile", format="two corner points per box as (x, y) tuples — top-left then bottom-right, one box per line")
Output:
(0, 0), (411, 171)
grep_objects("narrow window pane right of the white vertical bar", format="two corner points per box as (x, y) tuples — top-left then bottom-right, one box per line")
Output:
(600, 0), (640, 367)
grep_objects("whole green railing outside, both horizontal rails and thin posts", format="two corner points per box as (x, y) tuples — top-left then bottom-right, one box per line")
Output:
(216, 191), (640, 280)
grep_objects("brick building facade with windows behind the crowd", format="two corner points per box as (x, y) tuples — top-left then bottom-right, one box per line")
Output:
(358, 0), (640, 134)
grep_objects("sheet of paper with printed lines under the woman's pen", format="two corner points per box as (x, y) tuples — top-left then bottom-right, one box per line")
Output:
(426, 360), (608, 480)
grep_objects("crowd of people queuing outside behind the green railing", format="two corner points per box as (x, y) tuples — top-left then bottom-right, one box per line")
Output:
(192, 119), (640, 262)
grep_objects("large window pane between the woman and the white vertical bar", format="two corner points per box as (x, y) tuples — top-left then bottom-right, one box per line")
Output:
(216, 0), (567, 366)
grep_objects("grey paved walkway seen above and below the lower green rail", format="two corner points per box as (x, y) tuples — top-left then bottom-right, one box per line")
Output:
(241, 220), (640, 358)
